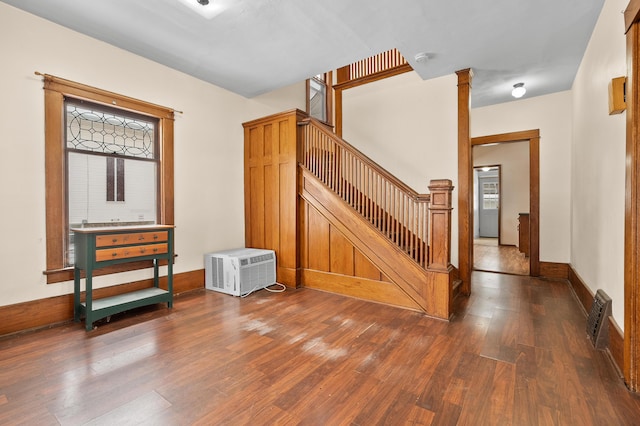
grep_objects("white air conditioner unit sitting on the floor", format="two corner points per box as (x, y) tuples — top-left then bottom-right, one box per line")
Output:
(204, 248), (276, 296)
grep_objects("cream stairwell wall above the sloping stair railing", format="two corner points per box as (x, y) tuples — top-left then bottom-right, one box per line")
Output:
(342, 72), (458, 265)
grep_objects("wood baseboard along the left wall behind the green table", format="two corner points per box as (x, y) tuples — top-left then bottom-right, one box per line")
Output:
(0, 269), (204, 336)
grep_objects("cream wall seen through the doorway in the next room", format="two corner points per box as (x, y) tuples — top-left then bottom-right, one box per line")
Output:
(473, 142), (529, 246)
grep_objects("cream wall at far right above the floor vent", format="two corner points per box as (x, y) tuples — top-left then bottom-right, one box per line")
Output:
(571, 0), (628, 328)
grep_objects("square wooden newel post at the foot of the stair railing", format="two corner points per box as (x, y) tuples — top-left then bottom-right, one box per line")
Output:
(427, 179), (453, 271)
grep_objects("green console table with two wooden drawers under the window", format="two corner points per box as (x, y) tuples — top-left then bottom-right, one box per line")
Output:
(72, 225), (174, 331)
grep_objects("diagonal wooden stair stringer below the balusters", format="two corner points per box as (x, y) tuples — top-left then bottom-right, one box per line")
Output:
(299, 167), (451, 319)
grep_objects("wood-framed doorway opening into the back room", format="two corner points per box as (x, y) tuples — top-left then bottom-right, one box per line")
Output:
(470, 130), (540, 276)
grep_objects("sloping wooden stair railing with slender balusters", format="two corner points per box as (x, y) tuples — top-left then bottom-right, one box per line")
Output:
(299, 119), (436, 268)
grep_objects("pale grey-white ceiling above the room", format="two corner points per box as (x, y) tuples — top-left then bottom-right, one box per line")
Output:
(1, 0), (608, 107)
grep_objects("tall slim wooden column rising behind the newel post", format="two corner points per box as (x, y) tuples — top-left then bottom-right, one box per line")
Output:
(456, 68), (473, 295)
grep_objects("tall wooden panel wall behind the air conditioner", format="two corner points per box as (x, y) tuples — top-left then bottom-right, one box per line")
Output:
(243, 110), (304, 287)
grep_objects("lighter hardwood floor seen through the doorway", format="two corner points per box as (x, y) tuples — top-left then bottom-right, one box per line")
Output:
(473, 238), (529, 275)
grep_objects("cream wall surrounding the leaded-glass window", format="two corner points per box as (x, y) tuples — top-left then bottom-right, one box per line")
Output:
(0, 3), (305, 305)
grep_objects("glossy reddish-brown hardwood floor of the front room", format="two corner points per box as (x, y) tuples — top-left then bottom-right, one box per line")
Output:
(0, 272), (640, 426)
